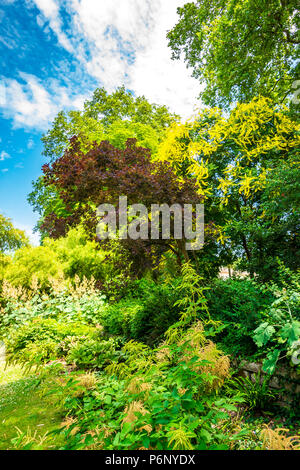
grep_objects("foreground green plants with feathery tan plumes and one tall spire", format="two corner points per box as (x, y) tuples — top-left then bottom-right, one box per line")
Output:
(52, 265), (242, 450)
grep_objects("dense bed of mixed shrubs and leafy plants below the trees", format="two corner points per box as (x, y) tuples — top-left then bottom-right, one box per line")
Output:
(1, 263), (299, 449)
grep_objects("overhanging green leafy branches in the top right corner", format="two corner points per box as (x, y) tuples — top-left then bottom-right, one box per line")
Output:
(168, 0), (300, 106)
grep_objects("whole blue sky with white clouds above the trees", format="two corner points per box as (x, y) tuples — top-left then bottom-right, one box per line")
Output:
(0, 0), (200, 243)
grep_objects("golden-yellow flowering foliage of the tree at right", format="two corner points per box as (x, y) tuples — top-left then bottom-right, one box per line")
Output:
(157, 96), (300, 204)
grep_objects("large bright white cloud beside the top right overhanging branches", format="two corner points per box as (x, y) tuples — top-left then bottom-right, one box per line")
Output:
(72, 0), (200, 116)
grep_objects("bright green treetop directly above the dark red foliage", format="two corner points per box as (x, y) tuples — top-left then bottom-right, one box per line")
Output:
(43, 87), (175, 160)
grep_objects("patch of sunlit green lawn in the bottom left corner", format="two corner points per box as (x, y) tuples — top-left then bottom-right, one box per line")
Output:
(0, 361), (62, 450)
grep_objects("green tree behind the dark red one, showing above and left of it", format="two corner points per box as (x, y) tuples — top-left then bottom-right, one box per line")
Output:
(28, 86), (178, 237)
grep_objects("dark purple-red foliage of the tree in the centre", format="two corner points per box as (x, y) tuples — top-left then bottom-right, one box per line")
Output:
(43, 136), (201, 269)
